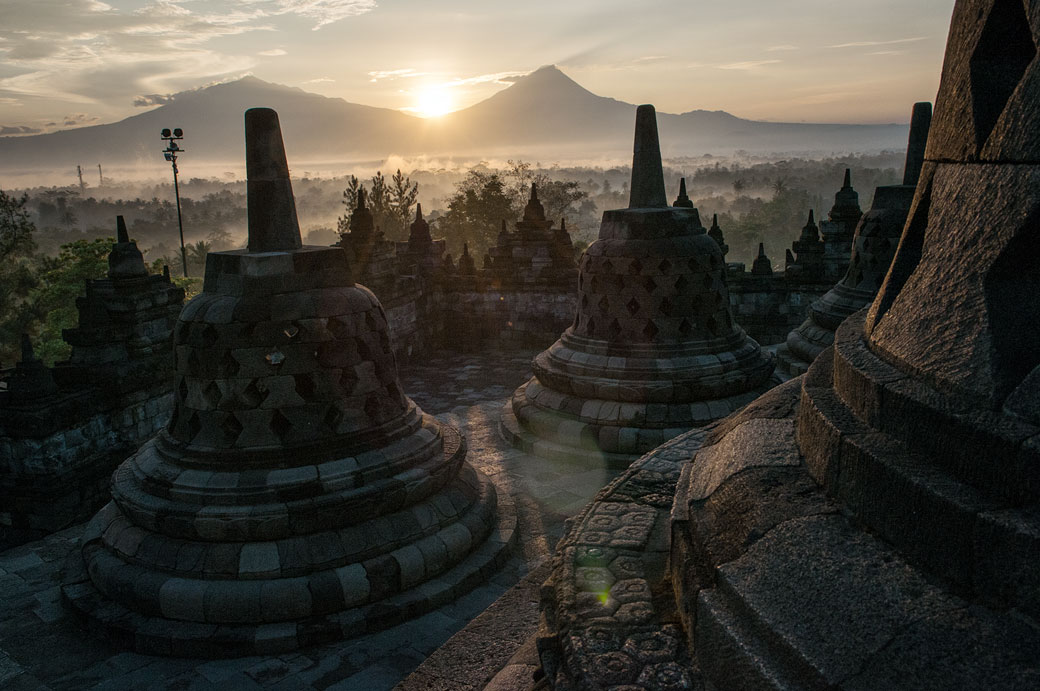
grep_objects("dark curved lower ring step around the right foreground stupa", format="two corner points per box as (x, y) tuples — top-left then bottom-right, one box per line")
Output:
(799, 352), (1040, 616)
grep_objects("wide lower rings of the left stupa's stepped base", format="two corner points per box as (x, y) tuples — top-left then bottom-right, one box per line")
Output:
(62, 426), (517, 658)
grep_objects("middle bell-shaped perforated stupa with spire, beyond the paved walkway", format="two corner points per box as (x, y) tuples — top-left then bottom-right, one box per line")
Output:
(502, 105), (773, 465)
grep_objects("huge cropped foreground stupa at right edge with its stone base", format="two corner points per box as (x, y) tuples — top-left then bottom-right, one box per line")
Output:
(669, 0), (1040, 689)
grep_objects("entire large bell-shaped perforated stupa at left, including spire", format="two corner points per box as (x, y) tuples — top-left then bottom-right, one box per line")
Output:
(63, 108), (515, 657)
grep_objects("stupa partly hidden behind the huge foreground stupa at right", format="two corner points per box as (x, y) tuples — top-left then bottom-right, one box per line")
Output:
(777, 103), (932, 376)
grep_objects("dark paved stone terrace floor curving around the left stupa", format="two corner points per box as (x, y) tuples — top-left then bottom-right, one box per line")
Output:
(0, 351), (613, 691)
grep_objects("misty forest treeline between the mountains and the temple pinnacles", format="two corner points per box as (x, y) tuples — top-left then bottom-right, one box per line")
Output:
(0, 153), (903, 363)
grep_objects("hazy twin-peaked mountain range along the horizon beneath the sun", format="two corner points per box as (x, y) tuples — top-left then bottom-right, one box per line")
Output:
(0, 66), (908, 174)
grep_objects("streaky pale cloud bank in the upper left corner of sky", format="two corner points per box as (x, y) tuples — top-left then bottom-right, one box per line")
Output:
(0, 0), (271, 111)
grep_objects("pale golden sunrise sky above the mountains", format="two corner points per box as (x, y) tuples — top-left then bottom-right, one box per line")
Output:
(0, 0), (954, 134)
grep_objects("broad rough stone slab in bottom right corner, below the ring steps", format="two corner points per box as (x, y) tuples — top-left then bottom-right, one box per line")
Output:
(694, 514), (1040, 689)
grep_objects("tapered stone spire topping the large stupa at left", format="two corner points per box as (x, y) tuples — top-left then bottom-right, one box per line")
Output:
(245, 108), (303, 252)
